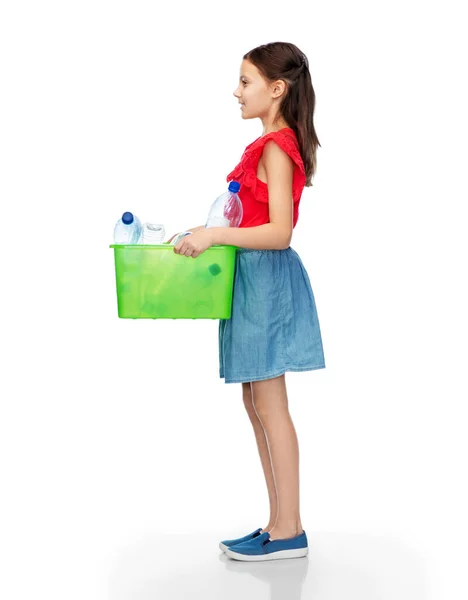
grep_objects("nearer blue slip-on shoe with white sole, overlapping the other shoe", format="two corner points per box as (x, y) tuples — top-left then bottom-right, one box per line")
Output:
(226, 531), (309, 561)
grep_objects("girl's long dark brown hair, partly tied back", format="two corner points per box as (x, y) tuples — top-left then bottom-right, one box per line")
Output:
(243, 42), (320, 187)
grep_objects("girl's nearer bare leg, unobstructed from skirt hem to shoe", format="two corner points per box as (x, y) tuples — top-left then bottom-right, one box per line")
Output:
(251, 375), (303, 540)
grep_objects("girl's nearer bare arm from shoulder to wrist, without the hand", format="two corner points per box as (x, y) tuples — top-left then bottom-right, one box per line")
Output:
(211, 140), (294, 250)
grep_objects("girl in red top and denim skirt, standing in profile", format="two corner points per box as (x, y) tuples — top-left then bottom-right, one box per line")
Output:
(174, 42), (325, 561)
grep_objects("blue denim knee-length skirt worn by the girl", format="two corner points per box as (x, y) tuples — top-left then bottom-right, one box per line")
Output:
(219, 247), (325, 383)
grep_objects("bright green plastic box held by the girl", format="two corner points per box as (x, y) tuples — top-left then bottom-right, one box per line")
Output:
(110, 244), (237, 319)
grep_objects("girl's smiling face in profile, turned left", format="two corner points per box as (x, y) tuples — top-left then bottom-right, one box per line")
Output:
(233, 60), (275, 119)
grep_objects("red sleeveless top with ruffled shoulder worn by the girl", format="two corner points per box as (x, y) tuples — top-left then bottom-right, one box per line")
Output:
(226, 127), (306, 228)
